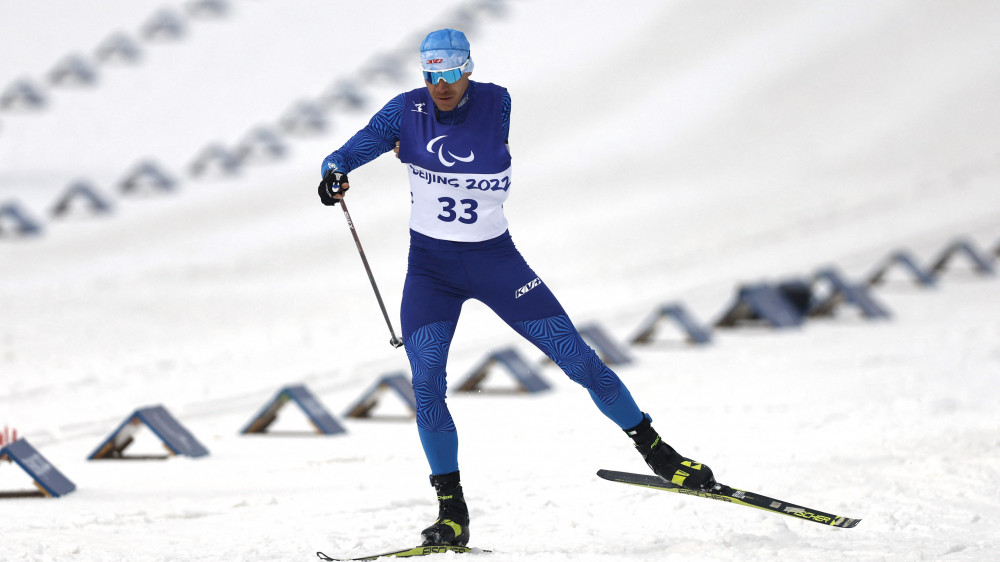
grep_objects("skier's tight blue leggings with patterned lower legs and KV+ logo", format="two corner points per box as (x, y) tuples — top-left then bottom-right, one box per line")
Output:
(401, 231), (642, 474)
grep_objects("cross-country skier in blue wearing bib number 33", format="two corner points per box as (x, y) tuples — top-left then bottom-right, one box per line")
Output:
(319, 29), (715, 545)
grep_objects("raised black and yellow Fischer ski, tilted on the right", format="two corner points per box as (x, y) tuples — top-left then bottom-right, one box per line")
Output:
(597, 469), (861, 529)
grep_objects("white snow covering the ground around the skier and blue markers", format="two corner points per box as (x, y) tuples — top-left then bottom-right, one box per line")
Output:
(0, 0), (1000, 562)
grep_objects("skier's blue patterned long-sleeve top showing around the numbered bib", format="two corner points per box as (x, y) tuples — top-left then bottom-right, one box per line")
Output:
(320, 80), (510, 176)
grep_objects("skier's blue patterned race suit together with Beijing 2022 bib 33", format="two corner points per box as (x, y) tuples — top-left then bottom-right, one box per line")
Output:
(323, 80), (643, 474)
